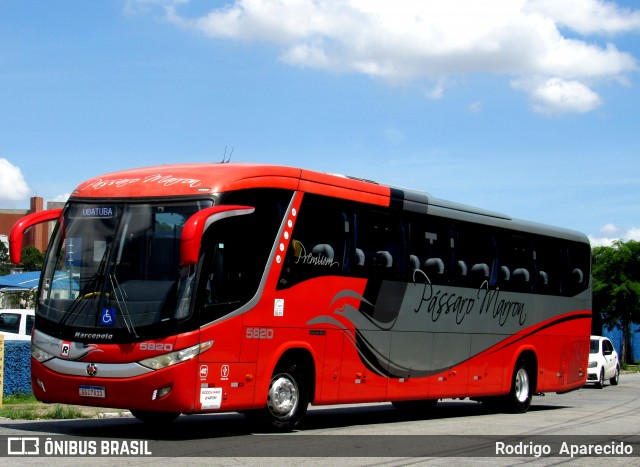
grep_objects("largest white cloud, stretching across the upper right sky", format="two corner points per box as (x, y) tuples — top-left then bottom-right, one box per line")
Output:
(159, 0), (640, 113)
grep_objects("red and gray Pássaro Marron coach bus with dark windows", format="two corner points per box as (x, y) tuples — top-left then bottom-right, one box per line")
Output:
(10, 163), (591, 430)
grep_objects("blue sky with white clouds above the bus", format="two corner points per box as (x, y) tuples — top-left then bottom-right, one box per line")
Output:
(0, 0), (640, 246)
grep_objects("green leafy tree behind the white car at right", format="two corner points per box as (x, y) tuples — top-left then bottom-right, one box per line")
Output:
(592, 240), (640, 363)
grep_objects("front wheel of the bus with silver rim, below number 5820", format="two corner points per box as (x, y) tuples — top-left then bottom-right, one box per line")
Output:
(257, 362), (309, 432)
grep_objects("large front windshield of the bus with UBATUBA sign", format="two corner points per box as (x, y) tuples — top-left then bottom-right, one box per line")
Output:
(36, 200), (213, 341)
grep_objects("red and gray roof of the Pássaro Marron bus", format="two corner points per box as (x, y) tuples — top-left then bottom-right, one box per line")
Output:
(71, 163), (589, 243)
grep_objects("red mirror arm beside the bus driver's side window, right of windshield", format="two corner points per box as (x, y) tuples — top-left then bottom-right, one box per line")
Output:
(180, 205), (255, 266)
